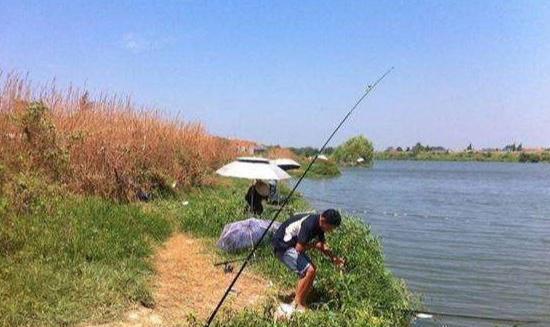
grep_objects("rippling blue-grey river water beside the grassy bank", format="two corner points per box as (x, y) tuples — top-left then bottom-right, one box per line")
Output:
(300, 161), (550, 326)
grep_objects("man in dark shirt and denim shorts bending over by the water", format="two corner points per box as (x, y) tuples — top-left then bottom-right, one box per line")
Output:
(273, 209), (344, 311)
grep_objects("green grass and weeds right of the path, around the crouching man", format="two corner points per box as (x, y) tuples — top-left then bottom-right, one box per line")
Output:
(180, 182), (413, 326)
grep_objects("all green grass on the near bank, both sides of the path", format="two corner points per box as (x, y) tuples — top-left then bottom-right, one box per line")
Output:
(0, 179), (413, 326)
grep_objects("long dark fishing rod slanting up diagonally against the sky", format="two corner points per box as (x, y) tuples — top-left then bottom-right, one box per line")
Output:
(206, 67), (393, 327)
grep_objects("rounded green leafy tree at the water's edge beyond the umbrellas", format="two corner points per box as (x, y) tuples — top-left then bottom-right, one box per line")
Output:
(332, 135), (374, 165)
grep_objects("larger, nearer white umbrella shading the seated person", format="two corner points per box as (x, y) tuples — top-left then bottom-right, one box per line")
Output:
(216, 157), (290, 180)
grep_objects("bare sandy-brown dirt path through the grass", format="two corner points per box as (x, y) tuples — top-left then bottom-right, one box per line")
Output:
(93, 234), (271, 327)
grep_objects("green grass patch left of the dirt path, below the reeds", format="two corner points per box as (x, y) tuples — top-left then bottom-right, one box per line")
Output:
(0, 188), (171, 326)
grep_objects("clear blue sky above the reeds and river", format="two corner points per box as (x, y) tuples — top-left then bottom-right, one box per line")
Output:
(0, 0), (550, 149)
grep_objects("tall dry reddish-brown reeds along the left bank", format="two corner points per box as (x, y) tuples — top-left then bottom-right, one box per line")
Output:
(0, 71), (240, 200)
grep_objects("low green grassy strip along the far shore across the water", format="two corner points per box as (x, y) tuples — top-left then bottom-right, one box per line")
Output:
(374, 151), (550, 162)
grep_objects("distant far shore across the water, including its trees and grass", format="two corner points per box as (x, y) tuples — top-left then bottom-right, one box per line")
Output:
(374, 143), (550, 162)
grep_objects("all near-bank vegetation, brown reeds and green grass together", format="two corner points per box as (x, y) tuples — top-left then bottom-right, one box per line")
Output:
(0, 76), (411, 326)
